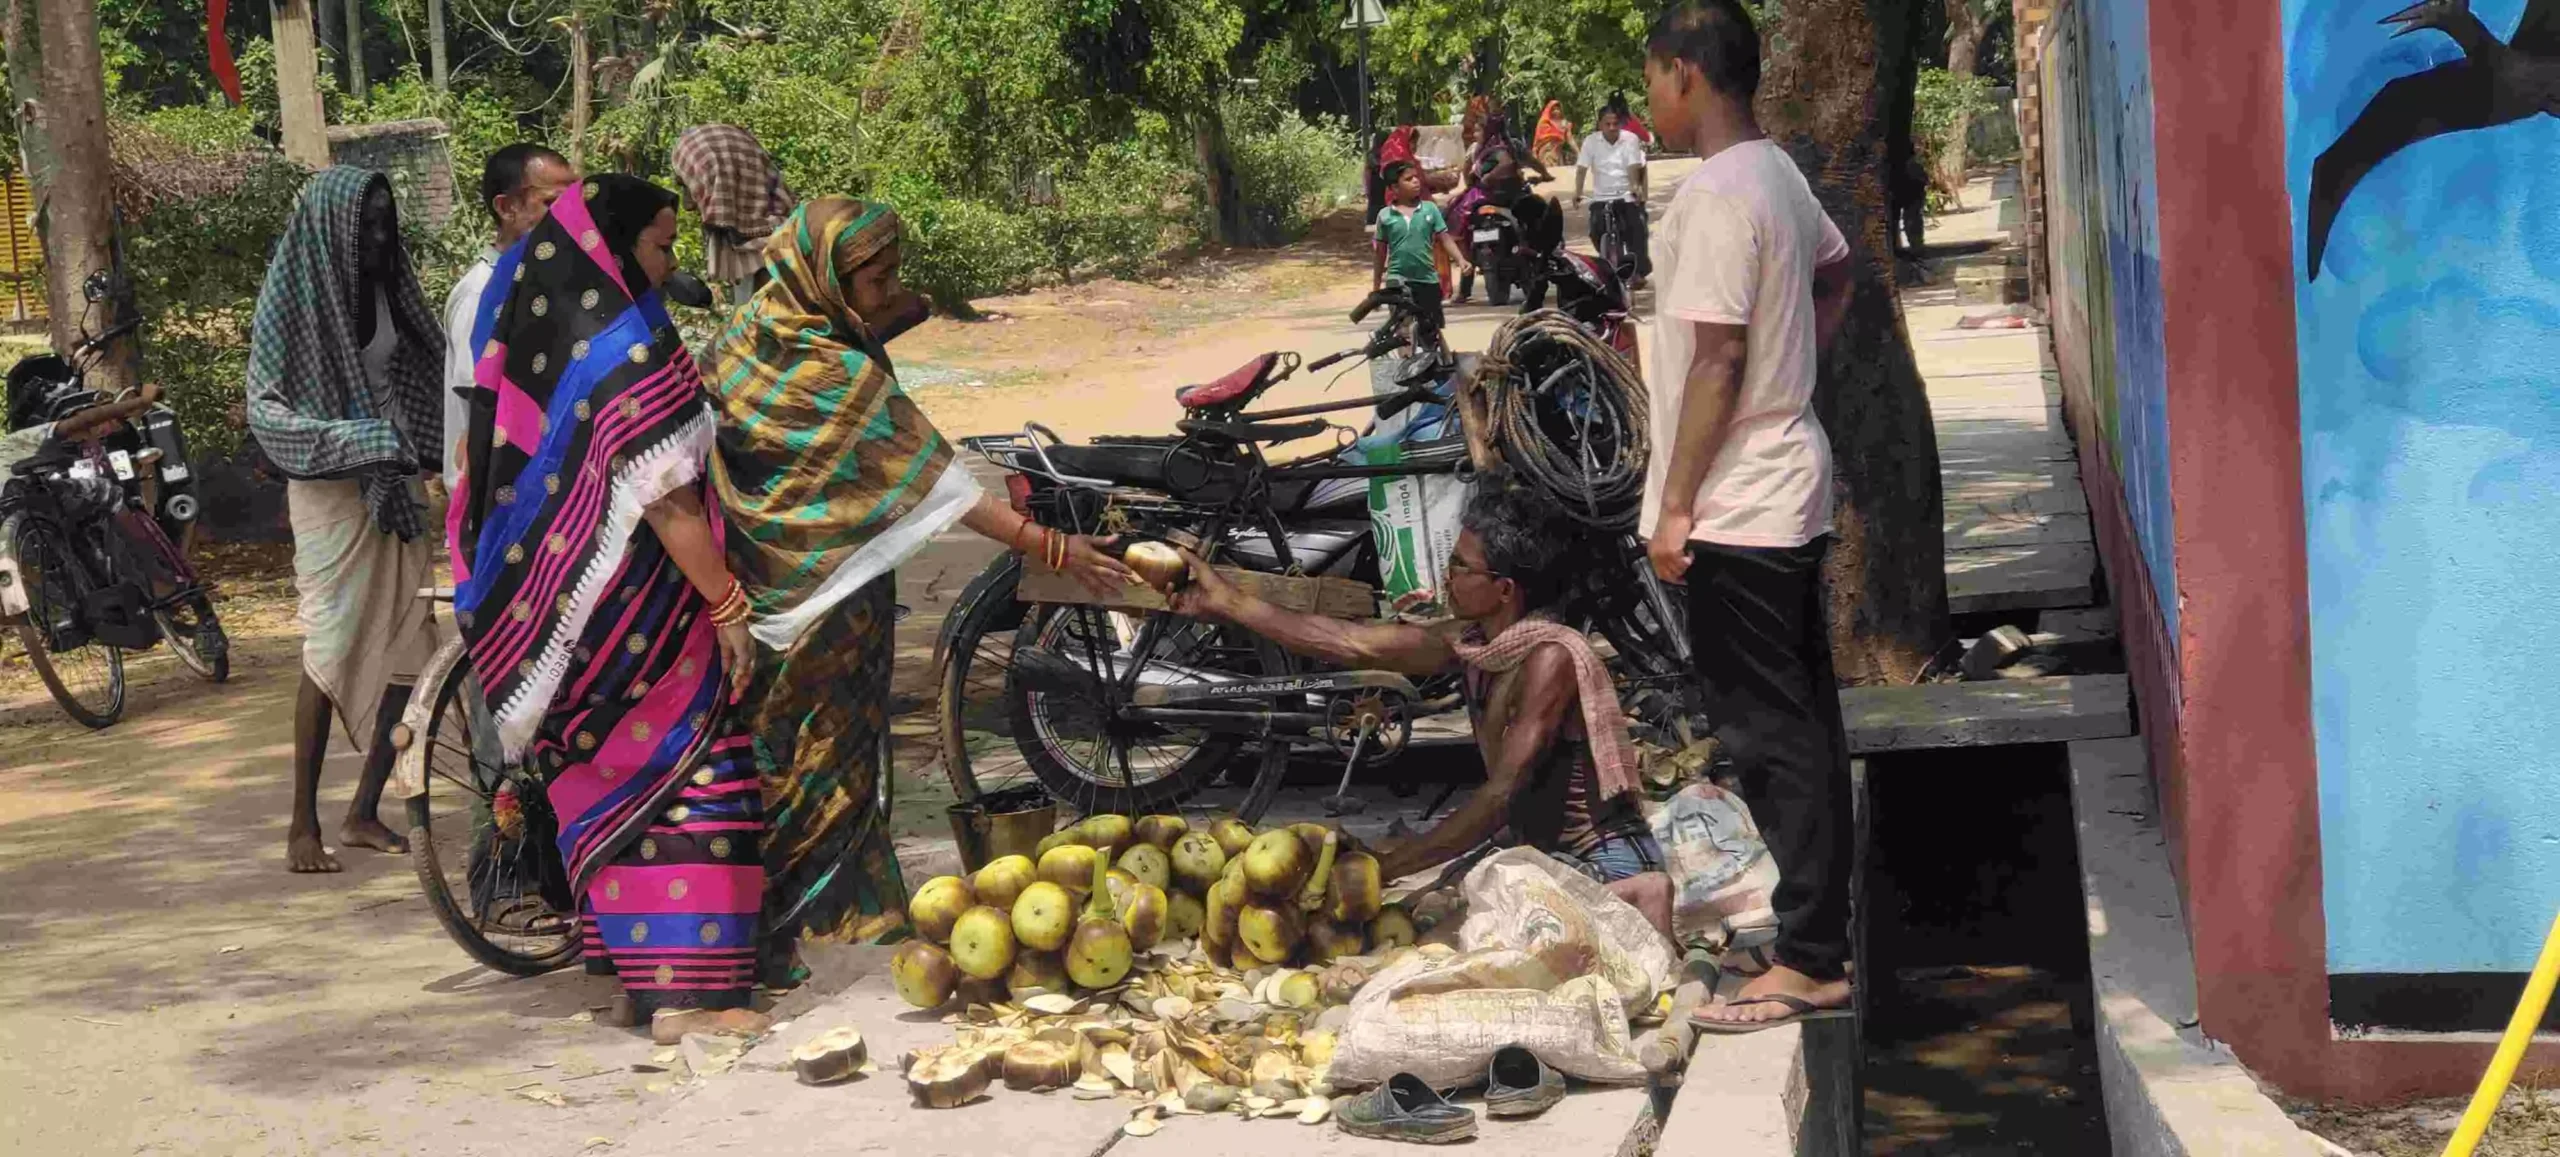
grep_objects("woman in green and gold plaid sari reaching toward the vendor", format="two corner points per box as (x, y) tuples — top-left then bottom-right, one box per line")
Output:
(712, 197), (1134, 985)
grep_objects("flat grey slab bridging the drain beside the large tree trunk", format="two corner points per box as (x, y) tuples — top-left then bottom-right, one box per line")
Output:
(1841, 676), (2132, 755)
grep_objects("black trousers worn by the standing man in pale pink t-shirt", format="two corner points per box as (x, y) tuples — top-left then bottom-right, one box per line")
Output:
(1687, 535), (1853, 980)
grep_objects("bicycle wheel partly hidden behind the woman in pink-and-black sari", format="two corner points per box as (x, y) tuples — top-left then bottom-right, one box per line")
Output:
(402, 640), (579, 975)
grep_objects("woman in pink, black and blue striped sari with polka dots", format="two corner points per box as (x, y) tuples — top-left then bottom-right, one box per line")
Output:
(448, 174), (763, 1042)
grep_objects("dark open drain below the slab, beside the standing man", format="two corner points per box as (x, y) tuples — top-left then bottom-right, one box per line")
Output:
(1859, 745), (2109, 1157)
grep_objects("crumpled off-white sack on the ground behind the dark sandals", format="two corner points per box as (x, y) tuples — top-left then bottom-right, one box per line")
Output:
(1329, 847), (1674, 1088)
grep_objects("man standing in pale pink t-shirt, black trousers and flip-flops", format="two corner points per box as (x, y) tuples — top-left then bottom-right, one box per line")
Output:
(1644, 0), (1851, 1032)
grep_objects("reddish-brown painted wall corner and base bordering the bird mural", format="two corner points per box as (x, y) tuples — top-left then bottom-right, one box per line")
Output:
(2119, 0), (2560, 1101)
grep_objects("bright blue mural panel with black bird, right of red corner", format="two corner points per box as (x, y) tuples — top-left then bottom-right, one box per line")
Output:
(2293, 0), (2560, 975)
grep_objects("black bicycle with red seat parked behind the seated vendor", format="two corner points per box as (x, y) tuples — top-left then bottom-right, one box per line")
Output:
(934, 289), (1687, 822)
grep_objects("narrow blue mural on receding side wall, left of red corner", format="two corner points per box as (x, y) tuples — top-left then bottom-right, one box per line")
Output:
(2045, 0), (2179, 637)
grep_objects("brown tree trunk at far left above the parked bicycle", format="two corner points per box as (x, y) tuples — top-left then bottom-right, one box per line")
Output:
(28, 0), (141, 394)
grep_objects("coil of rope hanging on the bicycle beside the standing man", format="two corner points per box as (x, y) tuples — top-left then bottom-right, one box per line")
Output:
(1457, 310), (1651, 530)
